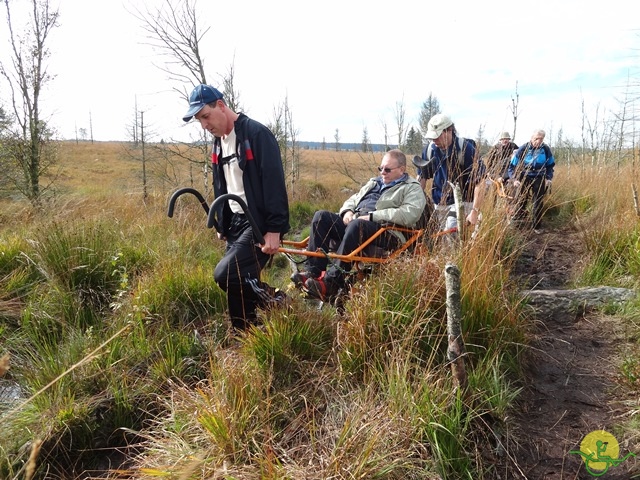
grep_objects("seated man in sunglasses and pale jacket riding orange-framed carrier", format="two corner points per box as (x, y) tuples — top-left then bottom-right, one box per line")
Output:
(291, 149), (427, 300)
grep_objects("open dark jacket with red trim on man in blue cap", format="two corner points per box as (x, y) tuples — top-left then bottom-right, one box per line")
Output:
(211, 113), (289, 235)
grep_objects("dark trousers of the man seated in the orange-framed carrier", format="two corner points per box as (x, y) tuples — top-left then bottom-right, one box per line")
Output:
(307, 210), (400, 285)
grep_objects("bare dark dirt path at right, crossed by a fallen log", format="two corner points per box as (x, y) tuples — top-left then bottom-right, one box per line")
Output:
(500, 227), (640, 480)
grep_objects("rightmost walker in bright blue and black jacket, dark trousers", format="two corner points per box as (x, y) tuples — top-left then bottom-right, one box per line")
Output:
(507, 130), (556, 233)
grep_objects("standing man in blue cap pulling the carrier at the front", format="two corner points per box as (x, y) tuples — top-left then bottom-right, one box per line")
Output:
(182, 85), (289, 330)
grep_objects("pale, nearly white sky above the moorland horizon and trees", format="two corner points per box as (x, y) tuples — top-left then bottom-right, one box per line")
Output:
(0, 0), (640, 143)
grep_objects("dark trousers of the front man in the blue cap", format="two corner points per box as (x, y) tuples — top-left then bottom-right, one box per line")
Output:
(213, 214), (275, 329)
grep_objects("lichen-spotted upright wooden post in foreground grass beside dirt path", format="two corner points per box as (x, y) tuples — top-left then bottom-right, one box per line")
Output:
(444, 263), (467, 389)
